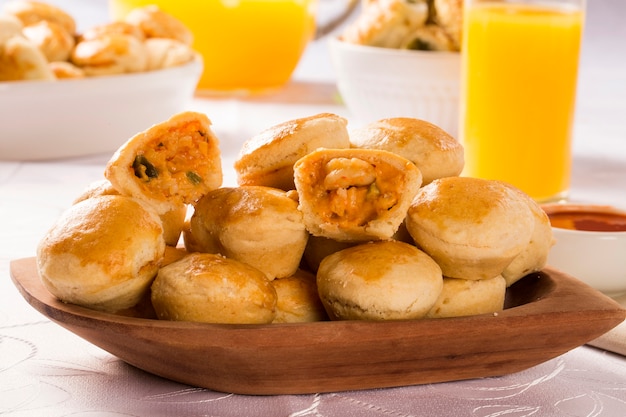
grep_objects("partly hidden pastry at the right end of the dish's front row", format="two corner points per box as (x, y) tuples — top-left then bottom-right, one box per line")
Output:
(426, 275), (506, 318)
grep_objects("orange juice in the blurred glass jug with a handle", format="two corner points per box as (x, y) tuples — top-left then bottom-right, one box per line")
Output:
(110, 0), (317, 92)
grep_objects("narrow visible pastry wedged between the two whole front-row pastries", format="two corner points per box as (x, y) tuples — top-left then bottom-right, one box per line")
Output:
(272, 269), (328, 323)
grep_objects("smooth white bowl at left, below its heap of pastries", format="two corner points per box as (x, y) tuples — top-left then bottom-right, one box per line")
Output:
(0, 59), (202, 160)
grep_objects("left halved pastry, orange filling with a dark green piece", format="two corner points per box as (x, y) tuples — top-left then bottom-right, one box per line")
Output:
(104, 112), (222, 214)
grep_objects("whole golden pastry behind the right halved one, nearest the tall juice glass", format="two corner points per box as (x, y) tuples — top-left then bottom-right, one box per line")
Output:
(350, 117), (465, 185)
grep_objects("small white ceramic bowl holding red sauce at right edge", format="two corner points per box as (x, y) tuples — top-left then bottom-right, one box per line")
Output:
(542, 204), (626, 297)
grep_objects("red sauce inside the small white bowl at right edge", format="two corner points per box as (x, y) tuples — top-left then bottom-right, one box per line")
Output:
(543, 204), (626, 232)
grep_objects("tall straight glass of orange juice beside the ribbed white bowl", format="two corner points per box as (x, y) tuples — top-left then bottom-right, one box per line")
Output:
(460, 0), (585, 202)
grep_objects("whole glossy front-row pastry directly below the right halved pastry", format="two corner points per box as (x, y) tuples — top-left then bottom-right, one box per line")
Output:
(317, 241), (443, 320)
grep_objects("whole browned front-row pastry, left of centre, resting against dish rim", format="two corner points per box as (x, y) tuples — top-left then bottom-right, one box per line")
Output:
(151, 253), (276, 324)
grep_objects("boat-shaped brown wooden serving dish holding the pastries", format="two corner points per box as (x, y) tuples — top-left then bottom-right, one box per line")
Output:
(11, 258), (626, 394)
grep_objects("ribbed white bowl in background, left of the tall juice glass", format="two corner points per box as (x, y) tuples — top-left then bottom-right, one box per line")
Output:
(329, 38), (461, 137)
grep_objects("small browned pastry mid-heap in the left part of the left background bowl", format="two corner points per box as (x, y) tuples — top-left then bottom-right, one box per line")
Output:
(22, 20), (76, 62)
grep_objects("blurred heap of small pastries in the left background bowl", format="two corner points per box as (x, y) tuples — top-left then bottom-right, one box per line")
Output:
(0, 0), (196, 81)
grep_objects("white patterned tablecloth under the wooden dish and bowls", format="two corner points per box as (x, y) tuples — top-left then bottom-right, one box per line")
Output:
(0, 0), (626, 417)
